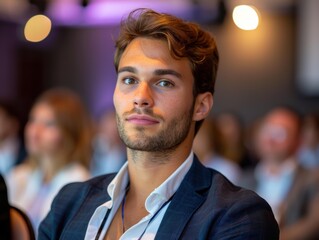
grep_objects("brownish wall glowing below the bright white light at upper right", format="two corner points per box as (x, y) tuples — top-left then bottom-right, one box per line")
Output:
(211, 12), (302, 121)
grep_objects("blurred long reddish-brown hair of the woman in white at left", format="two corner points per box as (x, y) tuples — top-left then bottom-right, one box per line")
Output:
(29, 88), (92, 171)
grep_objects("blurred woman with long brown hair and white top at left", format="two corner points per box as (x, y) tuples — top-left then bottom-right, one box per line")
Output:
(7, 89), (91, 232)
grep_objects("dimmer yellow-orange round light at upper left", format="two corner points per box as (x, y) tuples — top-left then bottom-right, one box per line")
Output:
(24, 14), (52, 42)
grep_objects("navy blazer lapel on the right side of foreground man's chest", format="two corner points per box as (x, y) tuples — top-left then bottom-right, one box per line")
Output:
(155, 156), (211, 240)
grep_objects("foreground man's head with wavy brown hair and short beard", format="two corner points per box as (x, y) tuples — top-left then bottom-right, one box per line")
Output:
(113, 9), (218, 154)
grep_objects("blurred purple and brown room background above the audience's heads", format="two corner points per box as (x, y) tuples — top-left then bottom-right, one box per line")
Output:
(0, 0), (319, 124)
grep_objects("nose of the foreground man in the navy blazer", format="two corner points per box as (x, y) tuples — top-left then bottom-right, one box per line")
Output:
(134, 83), (154, 108)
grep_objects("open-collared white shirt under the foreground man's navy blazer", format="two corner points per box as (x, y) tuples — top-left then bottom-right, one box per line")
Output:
(85, 152), (194, 240)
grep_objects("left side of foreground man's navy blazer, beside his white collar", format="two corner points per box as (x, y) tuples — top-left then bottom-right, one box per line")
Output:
(39, 174), (115, 239)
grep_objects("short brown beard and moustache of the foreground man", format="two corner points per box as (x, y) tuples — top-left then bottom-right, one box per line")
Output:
(116, 106), (194, 153)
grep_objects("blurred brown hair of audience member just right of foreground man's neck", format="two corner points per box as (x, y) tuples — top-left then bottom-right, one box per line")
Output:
(216, 112), (255, 169)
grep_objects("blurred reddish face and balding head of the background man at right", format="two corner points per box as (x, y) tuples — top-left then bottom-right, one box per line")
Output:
(257, 108), (300, 162)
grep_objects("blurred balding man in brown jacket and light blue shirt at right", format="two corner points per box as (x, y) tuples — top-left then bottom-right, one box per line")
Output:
(241, 108), (319, 240)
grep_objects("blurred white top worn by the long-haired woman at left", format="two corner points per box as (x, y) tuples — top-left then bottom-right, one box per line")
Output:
(7, 163), (90, 230)
